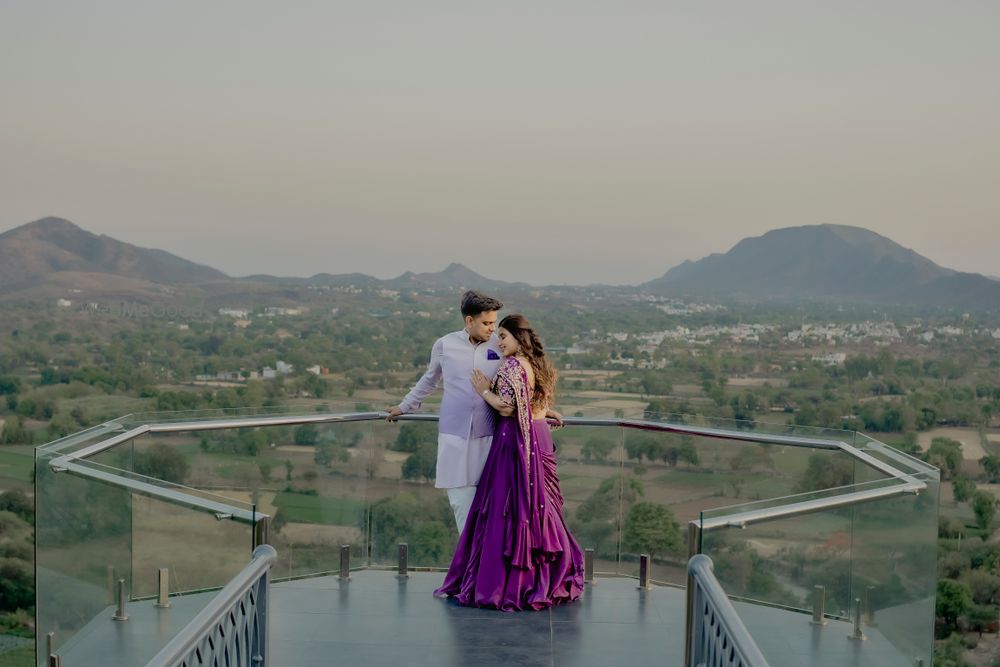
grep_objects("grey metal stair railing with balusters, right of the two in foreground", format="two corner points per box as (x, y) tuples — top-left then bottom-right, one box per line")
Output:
(684, 554), (768, 667)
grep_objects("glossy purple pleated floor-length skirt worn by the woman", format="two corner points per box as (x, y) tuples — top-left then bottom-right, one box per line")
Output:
(434, 414), (583, 611)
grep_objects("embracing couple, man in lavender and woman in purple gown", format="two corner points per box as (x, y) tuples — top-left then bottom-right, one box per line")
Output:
(389, 291), (583, 611)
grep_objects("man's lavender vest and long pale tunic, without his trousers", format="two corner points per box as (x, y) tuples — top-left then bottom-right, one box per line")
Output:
(399, 330), (501, 489)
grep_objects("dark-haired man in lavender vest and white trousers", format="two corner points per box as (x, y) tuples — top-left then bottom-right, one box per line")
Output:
(387, 290), (503, 533)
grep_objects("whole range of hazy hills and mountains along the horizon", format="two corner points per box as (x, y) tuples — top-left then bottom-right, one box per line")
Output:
(0, 217), (1000, 309)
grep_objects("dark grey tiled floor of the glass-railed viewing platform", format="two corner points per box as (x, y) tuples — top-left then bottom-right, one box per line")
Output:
(52, 570), (928, 667)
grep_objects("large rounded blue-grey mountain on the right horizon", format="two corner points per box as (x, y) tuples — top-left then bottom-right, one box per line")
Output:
(640, 225), (1000, 308)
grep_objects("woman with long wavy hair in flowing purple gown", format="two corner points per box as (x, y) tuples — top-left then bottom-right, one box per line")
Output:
(434, 315), (583, 611)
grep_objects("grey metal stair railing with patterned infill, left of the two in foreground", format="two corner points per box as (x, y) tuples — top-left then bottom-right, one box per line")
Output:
(146, 544), (278, 667)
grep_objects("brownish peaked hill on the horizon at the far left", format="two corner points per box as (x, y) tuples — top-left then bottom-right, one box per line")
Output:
(0, 218), (227, 292)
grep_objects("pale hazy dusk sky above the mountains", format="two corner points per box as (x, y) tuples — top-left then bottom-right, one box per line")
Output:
(0, 0), (1000, 284)
